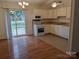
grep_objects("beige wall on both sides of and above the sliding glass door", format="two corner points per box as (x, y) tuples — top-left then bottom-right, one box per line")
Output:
(0, 2), (49, 39)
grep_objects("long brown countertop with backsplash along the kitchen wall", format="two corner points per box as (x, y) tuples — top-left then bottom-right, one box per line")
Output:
(33, 18), (70, 26)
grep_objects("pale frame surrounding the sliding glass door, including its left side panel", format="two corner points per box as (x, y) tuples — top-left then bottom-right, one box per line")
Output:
(6, 9), (27, 39)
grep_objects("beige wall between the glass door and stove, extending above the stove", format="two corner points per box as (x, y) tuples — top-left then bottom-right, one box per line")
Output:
(25, 8), (49, 35)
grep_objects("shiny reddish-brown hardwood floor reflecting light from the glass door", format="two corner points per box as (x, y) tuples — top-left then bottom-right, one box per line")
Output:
(0, 36), (79, 59)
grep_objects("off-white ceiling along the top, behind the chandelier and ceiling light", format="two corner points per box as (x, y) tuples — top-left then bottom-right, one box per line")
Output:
(0, 0), (71, 5)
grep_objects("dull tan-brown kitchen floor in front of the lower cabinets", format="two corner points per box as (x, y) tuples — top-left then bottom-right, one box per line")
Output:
(38, 34), (68, 52)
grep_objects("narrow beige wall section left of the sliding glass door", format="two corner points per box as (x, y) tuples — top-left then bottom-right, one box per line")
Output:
(0, 8), (6, 39)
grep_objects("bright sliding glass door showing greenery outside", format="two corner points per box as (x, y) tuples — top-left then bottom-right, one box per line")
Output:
(9, 10), (26, 37)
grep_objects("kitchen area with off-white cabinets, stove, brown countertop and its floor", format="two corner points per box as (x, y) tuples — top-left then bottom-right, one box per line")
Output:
(32, 0), (71, 52)
